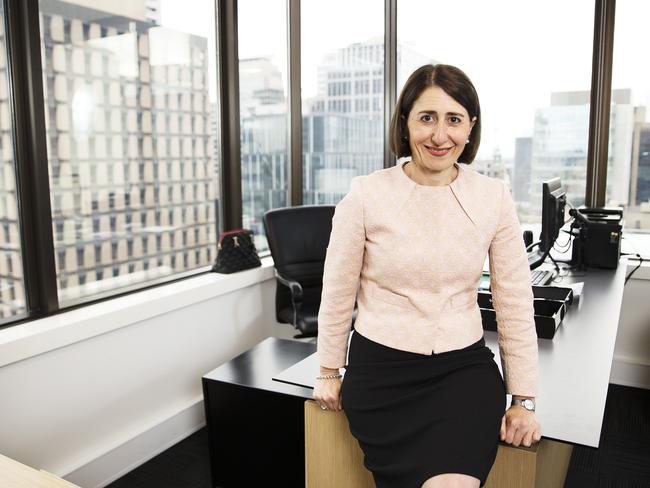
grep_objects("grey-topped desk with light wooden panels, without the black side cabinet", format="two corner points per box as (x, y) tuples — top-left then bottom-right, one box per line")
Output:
(296, 260), (626, 488)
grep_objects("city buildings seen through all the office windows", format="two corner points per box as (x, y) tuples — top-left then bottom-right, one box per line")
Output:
(0, 0), (650, 316)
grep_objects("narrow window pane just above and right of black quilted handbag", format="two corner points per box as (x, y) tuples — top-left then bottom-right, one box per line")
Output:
(238, 0), (289, 252)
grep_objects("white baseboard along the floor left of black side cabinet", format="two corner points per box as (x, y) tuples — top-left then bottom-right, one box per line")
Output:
(62, 396), (205, 488)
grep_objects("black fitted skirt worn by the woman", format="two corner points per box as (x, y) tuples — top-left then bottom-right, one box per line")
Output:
(341, 332), (506, 488)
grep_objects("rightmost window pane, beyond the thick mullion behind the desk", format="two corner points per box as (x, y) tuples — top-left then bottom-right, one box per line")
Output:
(607, 0), (650, 232)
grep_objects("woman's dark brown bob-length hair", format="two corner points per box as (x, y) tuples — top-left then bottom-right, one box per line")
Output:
(388, 64), (481, 164)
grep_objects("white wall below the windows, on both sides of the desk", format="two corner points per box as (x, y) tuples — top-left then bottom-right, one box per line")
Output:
(0, 262), (650, 488)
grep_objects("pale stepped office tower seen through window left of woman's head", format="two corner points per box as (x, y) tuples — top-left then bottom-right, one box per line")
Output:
(302, 38), (431, 204)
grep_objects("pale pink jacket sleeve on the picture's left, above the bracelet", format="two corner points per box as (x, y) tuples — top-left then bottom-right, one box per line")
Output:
(318, 176), (366, 368)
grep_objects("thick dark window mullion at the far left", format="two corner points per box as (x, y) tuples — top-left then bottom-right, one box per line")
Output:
(6, 0), (59, 317)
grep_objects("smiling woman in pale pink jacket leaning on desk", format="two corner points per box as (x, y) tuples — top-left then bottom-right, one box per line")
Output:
(314, 64), (541, 488)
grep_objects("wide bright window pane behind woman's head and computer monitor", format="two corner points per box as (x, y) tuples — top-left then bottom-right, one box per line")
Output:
(397, 0), (594, 222)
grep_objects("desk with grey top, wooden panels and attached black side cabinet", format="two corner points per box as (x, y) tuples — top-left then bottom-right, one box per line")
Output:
(203, 260), (626, 488)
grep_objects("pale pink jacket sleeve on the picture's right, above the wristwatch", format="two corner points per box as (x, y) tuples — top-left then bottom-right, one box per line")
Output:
(489, 182), (538, 397)
